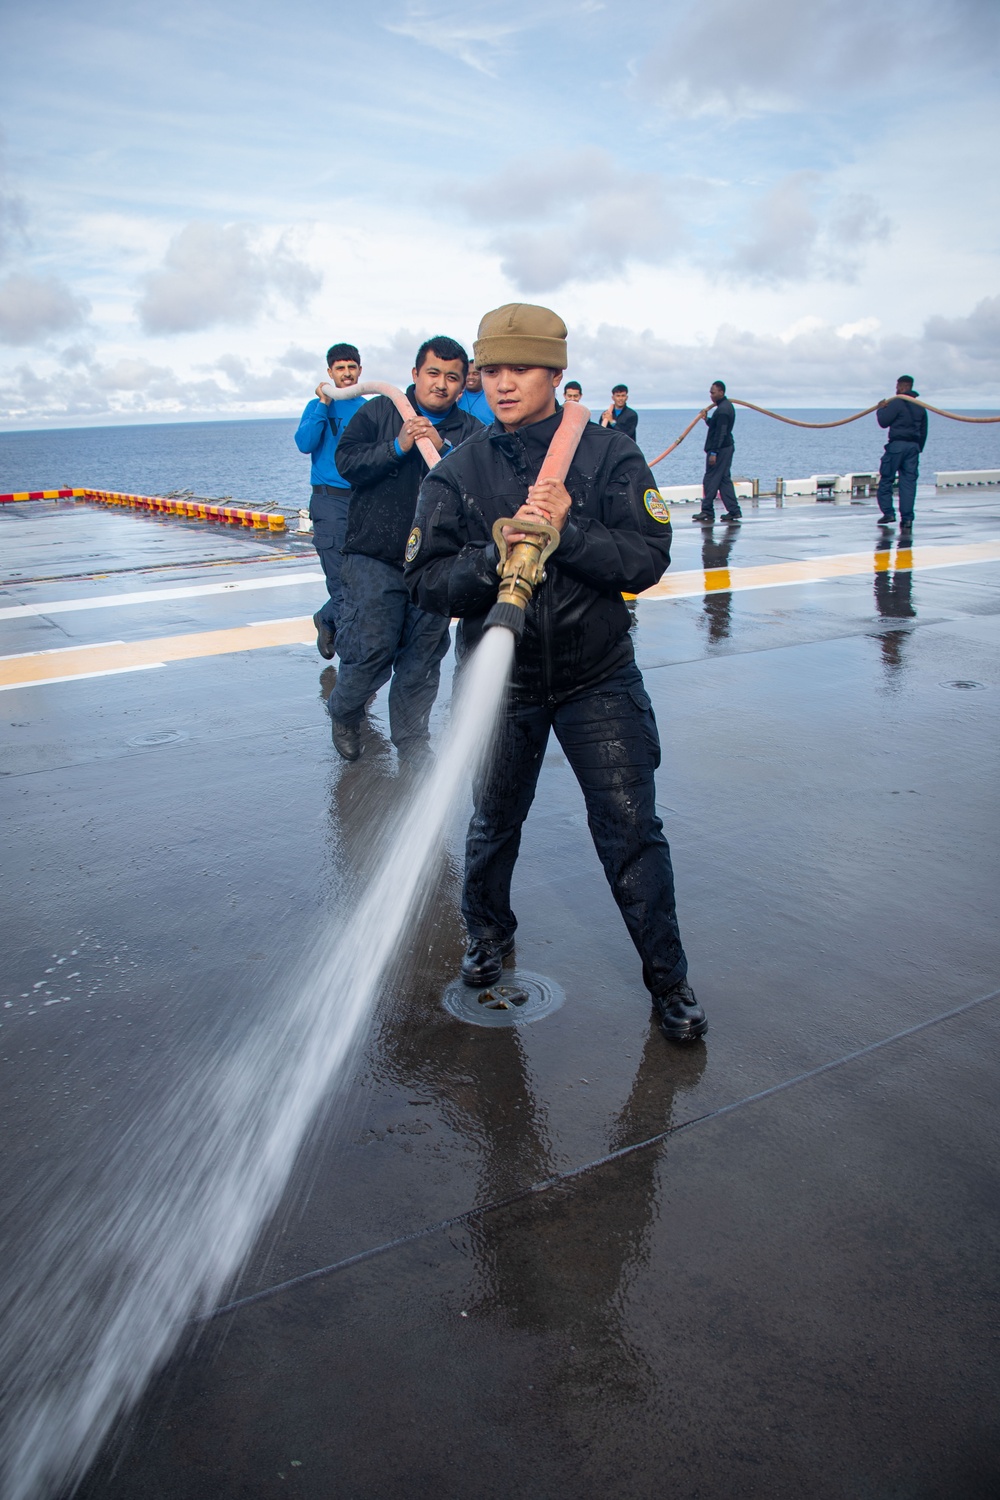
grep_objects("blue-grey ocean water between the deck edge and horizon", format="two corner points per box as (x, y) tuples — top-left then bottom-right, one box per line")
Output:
(0, 410), (1000, 510)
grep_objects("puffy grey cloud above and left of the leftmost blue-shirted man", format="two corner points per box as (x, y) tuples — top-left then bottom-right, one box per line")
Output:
(136, 224), (321, 333)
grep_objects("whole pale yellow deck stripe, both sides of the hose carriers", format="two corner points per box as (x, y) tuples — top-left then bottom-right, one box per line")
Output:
(0, 542), (1000, 692)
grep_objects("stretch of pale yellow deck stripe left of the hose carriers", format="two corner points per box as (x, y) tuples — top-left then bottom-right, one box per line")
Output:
(0, 615), (316, 689)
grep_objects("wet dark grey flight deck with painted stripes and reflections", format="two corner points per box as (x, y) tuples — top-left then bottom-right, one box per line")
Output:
(0, 489), (1000, 1500)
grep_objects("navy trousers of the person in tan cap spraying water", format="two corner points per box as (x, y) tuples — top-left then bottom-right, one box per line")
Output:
(462, 662), (688, 995)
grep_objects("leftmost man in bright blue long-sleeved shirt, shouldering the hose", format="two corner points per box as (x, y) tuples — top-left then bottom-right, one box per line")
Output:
(295, 344), (364, 662)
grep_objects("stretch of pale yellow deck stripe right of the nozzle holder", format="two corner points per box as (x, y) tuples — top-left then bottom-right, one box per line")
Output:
(639, 542), (1000, 599)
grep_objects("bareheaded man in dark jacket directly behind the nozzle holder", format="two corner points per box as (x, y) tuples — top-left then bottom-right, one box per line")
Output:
(327, 336), (484, 764)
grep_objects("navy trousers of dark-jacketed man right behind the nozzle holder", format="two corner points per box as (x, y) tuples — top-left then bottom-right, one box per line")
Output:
(327, 552), (450, 755)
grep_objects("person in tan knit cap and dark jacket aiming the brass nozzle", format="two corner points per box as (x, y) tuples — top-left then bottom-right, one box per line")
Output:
(406, 303), (708, 1041)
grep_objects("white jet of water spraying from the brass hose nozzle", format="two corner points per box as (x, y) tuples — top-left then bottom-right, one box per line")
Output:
(0, 629), (514, 1500)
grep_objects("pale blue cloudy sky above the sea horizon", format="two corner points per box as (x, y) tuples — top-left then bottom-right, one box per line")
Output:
(0, 0), (1000, 428)
